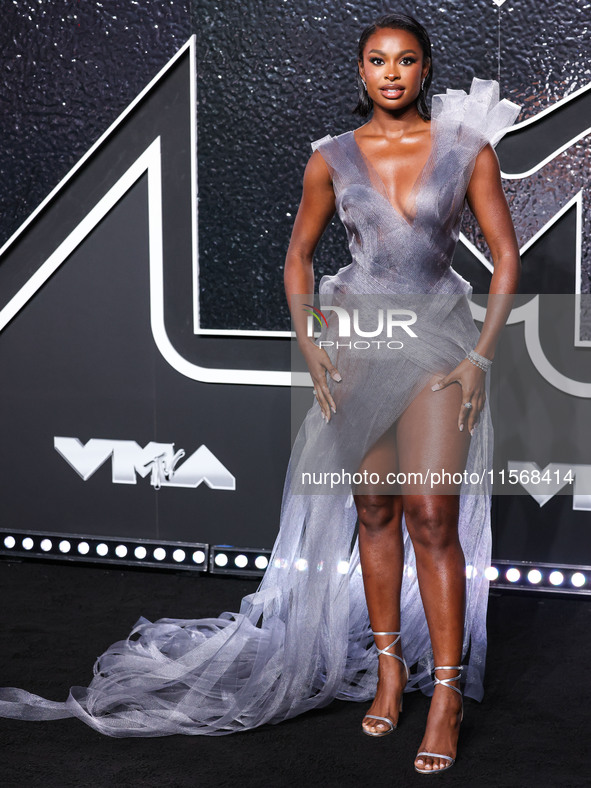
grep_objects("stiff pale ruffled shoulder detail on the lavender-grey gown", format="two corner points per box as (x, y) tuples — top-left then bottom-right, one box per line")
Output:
(431, 77), (521, 147)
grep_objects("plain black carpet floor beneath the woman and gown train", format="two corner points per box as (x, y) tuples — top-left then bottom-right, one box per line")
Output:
(0, 560), (591, 788)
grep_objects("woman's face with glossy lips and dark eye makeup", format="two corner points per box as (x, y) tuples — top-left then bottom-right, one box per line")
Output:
(359, 28), (429, 110)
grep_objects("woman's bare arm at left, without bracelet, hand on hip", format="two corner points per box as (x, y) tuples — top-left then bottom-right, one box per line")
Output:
(283, 151), (341, 421)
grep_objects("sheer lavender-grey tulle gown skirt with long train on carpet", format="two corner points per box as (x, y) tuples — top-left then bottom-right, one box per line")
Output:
(0, 290), (492, 737)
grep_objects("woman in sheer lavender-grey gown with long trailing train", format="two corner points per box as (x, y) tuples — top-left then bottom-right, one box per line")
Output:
(0, 9), (519, 772)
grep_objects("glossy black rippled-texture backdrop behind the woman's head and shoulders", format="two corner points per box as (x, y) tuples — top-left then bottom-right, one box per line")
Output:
(0, 0), (591, 329)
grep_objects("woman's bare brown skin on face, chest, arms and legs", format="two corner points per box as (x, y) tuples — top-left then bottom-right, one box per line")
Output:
(284, 28), (521, 770)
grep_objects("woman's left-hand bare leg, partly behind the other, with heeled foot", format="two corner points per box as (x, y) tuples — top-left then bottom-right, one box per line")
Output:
(354, 430), (406, 732)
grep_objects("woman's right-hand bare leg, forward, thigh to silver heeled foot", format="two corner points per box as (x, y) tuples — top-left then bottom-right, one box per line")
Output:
(396, 378), (470, 770)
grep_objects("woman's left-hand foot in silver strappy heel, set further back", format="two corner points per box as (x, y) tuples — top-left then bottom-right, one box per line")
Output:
(361, 635), (408, 736)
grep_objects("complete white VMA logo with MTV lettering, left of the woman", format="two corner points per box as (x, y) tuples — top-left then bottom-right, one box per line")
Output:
(53, 438), (236, 490)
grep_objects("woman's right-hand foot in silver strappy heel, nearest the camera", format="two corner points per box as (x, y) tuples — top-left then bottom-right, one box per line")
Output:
(415, 669), (462, 771)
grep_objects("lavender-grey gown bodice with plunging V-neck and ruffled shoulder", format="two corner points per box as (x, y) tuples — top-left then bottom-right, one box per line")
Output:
(311, 77), (521, 295)
